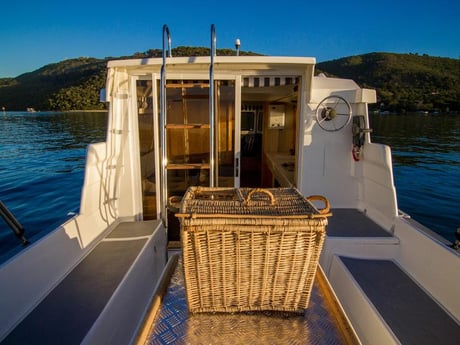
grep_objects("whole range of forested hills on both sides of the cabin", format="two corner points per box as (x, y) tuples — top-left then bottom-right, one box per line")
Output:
(0, 47), (460, 111)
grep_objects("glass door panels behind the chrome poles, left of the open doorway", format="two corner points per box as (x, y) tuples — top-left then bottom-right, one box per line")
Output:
(157, 77), (236, 241)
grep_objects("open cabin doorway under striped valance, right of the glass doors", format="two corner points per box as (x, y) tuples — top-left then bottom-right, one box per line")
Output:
(240, 76), (302, 188)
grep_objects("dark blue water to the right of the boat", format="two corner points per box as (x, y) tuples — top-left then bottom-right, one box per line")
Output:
(370, 115), (460, 241)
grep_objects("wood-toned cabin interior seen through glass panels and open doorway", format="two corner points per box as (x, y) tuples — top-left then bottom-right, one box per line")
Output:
(136, 77), (300, 241)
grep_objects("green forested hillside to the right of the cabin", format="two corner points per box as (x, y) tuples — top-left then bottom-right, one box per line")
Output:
(317, 53), (460, 112)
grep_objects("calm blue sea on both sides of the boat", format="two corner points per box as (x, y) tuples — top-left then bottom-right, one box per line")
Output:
(0, 112), (460, 261)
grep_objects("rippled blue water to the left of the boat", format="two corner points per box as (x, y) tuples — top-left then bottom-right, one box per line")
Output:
(0, 112), (107, 256)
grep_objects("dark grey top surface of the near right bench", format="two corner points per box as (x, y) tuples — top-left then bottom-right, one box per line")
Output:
(340, 256), (460, 345)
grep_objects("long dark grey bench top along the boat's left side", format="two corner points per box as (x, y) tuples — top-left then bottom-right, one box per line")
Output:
(1, 221), (164, 345)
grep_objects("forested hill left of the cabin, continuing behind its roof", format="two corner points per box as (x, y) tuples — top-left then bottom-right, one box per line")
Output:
(0, 47), (260, 111)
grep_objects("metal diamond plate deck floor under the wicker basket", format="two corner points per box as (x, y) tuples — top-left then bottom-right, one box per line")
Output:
(147, 260), (344, 345)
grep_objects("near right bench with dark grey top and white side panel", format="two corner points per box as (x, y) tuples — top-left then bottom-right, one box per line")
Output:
(329, 256), (460, 345)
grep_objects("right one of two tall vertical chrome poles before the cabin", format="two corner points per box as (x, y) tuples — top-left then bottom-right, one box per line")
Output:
(209, 24), (216, 187)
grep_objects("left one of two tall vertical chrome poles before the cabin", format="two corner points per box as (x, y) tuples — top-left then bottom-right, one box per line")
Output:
(160, 24), (171, 227)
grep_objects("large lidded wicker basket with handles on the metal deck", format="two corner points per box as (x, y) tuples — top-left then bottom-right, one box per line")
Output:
(176, 187), (331, 313)
